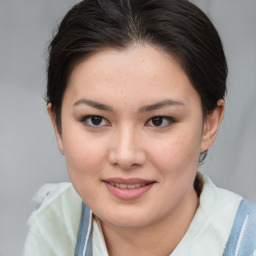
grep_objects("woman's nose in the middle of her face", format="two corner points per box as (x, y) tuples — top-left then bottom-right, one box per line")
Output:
(109, 127), (146, 170)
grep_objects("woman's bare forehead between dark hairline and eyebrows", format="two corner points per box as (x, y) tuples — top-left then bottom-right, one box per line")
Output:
(64, 45), (199, 107)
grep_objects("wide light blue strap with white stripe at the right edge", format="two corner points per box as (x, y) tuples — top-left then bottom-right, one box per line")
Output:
(223, 199), (256, 256)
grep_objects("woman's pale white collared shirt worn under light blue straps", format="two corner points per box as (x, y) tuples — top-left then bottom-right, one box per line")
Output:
(24, 175), (242, 256)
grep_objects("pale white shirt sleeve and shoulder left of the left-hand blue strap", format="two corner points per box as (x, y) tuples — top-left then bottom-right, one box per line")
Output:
(24, 183), (82, 256)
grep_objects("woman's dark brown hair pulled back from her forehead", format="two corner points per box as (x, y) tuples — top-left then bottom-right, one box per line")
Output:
(46, 0), (227, 160)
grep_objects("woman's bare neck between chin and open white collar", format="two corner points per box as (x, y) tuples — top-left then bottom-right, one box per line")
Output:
(101, 186), (199, 256)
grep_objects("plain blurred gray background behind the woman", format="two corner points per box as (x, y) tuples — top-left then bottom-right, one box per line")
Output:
(0, 0), (256, 256)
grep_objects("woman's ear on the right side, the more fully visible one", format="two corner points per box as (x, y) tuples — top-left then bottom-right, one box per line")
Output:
(201, 99), (225, 152)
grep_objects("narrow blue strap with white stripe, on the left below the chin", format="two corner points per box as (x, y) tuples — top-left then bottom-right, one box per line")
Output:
(75, 203), (93, 256)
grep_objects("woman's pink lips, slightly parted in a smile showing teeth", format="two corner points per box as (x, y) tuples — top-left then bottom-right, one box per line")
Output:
(103, 178), (156, 200)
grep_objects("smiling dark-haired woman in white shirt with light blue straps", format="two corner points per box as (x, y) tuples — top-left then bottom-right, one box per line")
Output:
(25, 0), (256, 256)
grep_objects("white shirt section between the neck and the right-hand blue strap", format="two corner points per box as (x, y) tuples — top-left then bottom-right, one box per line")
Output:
(173, 174), (242, 256)
